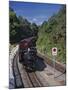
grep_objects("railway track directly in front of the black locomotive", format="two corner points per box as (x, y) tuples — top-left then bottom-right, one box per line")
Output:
(26, 71), (43, 87)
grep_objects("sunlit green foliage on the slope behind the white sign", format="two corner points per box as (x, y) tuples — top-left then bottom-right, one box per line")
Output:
(37, 5), (66, 63)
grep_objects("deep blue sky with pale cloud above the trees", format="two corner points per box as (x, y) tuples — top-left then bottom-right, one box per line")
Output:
(9, 1), (62, 25)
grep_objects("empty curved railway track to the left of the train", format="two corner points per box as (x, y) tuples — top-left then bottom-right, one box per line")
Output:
(12, 54), (24, 88)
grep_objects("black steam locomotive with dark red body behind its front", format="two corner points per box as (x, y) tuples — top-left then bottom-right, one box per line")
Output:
(19, 37), (37, 70)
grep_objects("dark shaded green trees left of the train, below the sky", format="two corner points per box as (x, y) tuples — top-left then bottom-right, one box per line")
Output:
(9, 8), (38, 43)
